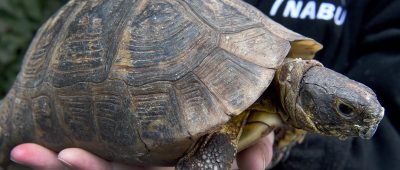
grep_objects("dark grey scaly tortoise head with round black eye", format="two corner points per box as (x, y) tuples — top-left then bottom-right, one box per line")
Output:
(278, 60), (384, 139)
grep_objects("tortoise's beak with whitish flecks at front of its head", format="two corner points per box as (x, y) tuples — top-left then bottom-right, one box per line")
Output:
(359, 107), (385, 139)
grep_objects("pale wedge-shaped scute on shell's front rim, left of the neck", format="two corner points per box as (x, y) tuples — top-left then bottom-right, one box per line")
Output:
(194, 49), (275, 115)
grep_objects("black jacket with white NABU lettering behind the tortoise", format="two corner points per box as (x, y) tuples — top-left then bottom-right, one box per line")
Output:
(245, 0), (400, 170)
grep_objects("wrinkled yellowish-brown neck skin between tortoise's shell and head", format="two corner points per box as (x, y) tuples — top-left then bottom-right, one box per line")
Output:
(274, 58), (322, 133)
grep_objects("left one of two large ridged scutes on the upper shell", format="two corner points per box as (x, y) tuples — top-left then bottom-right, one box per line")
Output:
(48, 1), (136, 87)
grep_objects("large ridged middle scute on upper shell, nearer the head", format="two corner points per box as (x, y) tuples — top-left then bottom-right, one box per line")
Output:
(111, 1), (218, 86)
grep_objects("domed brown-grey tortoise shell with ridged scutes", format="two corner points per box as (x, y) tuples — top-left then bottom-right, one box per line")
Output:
(5, 0), (316, 165)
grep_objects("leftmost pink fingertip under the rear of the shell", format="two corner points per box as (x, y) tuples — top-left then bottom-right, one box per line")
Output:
(11, 143), (65, 170)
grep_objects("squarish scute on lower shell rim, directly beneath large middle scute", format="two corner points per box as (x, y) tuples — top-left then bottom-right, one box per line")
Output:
(129, 82), (188, 150)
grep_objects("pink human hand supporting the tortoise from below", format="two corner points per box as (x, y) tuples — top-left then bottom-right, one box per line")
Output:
(11, 134), (274, 170)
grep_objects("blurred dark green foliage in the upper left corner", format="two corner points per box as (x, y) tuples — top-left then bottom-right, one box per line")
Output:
(0, 0), (67, 99)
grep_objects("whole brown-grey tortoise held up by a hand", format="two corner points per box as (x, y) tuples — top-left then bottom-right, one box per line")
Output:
(0, 0), (384, 169)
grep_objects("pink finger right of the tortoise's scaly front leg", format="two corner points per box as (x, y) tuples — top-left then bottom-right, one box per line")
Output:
(237, 133), (274, 170)
